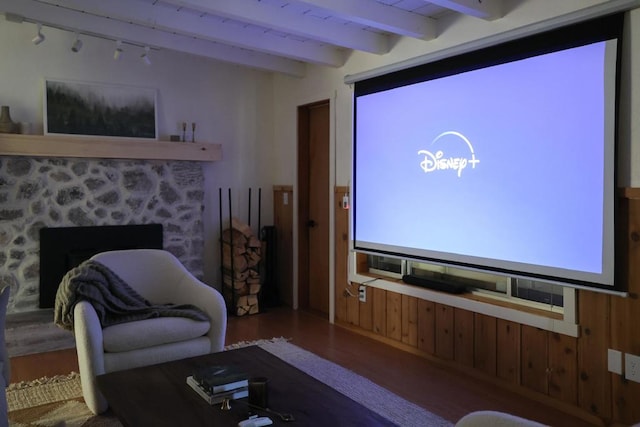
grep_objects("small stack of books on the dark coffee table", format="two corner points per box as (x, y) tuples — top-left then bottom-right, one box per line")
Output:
(187, 365), (249, 405)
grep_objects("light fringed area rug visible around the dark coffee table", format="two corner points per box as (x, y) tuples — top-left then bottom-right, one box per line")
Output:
(7, 338), (452, 427)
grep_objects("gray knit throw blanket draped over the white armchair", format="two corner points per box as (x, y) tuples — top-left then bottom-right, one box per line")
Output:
(54, 260), (209, 331)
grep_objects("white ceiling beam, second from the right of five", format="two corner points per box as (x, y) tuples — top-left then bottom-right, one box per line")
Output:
(302, 0), (436, 40)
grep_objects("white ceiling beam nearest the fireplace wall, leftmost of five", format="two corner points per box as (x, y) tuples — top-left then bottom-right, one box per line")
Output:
(0, 0), (306, 77)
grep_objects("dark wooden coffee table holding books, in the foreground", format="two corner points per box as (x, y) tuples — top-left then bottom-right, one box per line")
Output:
(97, 346), (395, 427)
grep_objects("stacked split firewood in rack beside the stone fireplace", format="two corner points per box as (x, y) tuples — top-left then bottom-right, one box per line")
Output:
(222, 218), (262, 316)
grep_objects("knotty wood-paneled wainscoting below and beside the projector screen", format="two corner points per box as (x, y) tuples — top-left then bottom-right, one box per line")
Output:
(334, 187), (640, 425)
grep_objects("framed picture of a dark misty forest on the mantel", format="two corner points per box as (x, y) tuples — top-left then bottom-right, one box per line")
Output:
(44, 80), (158, 139)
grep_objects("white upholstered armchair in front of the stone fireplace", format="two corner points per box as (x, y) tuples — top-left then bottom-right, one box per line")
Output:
(73, 249), (227, 414)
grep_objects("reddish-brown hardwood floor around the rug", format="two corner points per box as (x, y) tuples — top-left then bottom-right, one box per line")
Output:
(11, 307), (589, 426)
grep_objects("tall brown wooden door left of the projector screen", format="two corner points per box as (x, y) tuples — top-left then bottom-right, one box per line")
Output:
(298, 100), (330, 315)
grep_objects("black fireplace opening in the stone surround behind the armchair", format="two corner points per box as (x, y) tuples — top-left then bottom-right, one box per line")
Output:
(39, 224), (163, 308)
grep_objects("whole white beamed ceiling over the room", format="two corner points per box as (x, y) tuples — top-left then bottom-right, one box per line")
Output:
(0, 0), (509, 76)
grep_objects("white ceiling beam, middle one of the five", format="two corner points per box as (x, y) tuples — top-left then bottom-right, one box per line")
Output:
(166, 0), (390, 55)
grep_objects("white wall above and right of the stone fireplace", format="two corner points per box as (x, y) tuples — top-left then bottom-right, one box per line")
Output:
(0, 17), (274, 284)
